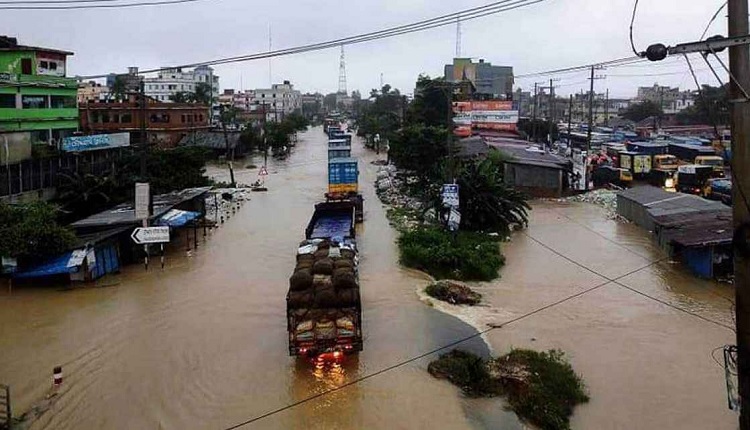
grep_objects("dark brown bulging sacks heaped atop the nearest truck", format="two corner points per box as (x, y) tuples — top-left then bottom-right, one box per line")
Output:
(287, 239), (360, 309)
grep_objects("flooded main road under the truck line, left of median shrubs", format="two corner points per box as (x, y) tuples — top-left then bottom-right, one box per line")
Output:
(0, 128), (506, 430)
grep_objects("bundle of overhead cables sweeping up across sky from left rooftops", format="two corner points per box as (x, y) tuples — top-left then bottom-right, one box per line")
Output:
(80, 0), (547, 79)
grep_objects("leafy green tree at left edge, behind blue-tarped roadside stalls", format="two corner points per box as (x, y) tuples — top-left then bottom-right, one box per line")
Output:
(0, 202), (76, 265)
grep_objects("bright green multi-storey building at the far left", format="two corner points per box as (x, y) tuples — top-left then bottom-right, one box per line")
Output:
(0, 36), (78, 164)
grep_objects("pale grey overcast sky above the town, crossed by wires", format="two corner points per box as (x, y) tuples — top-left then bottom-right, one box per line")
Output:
(0, 0), (726, 97)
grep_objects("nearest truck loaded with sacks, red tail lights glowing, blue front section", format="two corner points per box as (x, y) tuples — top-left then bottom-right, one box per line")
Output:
(286, 202), (363, 359)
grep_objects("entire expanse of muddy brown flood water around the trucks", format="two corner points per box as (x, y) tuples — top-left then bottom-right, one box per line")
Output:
(0, 128), (736, 430)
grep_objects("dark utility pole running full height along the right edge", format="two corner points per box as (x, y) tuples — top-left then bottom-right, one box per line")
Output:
(727, 0), (750, 430)
